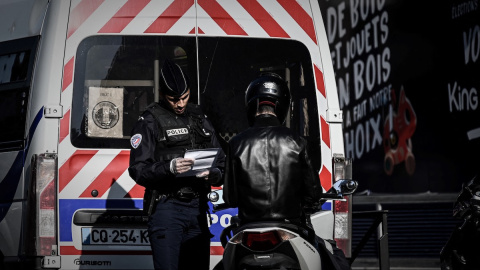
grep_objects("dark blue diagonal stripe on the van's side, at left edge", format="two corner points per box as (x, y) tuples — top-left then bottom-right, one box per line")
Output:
(0, 107), (43, 222)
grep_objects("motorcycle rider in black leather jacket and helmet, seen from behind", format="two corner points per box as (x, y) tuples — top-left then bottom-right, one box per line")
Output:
(223, 73), (350, 269)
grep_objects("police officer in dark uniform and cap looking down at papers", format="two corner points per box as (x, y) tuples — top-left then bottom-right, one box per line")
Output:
(128, 60), (225, 270)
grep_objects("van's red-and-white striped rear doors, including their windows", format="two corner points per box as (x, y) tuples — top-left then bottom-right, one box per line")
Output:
(58, 0), (343, 269)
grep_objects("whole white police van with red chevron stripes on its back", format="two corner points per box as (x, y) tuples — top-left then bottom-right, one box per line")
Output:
(0, 0), (351, 269)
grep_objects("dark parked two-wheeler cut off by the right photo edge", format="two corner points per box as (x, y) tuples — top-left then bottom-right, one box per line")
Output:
(440, 176), (480, 270)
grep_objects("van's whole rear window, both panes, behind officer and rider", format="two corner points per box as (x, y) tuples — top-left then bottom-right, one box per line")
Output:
(71, 36), (320, 169)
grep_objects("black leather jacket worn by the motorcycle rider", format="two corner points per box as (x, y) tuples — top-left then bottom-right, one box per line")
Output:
(223, 115), (322, 222)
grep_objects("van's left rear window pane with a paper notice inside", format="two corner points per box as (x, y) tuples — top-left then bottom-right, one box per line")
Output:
(71, 36), (197, 148)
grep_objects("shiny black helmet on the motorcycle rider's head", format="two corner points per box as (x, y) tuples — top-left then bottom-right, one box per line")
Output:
(245, 73), (290, 123)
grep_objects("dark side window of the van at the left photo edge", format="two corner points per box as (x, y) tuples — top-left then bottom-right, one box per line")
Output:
(0, 37), (38, 151)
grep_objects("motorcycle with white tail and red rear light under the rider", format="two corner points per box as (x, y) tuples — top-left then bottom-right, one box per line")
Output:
(211, 180), (358, 270)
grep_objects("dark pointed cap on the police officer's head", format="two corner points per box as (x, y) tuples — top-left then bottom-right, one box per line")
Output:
(160, 59), (190, 97)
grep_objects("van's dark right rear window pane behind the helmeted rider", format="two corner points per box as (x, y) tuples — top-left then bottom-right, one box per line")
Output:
(198, 37), (321, 169)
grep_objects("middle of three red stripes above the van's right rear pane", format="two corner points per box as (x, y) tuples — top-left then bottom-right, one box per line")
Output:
(238, 0), (290, 38)
